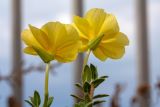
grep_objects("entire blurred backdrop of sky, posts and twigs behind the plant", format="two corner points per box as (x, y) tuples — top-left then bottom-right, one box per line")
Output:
(0, 0), (160, 107)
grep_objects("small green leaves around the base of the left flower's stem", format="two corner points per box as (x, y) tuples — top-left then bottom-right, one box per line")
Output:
(25, 91), (53, 107)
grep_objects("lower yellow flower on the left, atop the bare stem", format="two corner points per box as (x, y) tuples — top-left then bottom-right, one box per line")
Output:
(22, 22), (80, 63)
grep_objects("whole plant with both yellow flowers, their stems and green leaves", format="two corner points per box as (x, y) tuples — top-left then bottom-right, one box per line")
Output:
(22, 8), (129, 107)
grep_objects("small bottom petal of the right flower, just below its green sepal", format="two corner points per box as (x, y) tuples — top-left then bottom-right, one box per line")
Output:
(93, 48), (107, 61)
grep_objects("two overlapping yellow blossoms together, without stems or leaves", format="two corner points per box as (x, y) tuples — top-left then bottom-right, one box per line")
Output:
(22, 8), (129, 63)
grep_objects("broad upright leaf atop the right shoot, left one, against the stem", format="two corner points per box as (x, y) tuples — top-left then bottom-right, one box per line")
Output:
(82, 65), (92, 83)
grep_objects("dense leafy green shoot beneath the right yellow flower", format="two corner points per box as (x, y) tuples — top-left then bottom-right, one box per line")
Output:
(71, 64), (109, 107)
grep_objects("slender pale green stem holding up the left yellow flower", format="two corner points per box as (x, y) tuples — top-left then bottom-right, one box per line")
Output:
(43, 63), (50, 107)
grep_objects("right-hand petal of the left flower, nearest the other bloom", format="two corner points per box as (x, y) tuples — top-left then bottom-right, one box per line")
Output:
(55, 25), (81, 62)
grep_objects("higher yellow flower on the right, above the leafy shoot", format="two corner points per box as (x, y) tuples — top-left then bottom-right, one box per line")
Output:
(73, 8), (129, 61)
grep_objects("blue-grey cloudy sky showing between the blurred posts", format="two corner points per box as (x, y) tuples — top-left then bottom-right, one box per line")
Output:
(0, 0), (160, 107)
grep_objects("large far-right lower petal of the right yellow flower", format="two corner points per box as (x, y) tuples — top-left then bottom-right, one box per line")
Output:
(98, 32), (129, 59)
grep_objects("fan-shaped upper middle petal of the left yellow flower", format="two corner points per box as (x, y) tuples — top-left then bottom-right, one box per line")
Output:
(41, 22), (67, 51)
